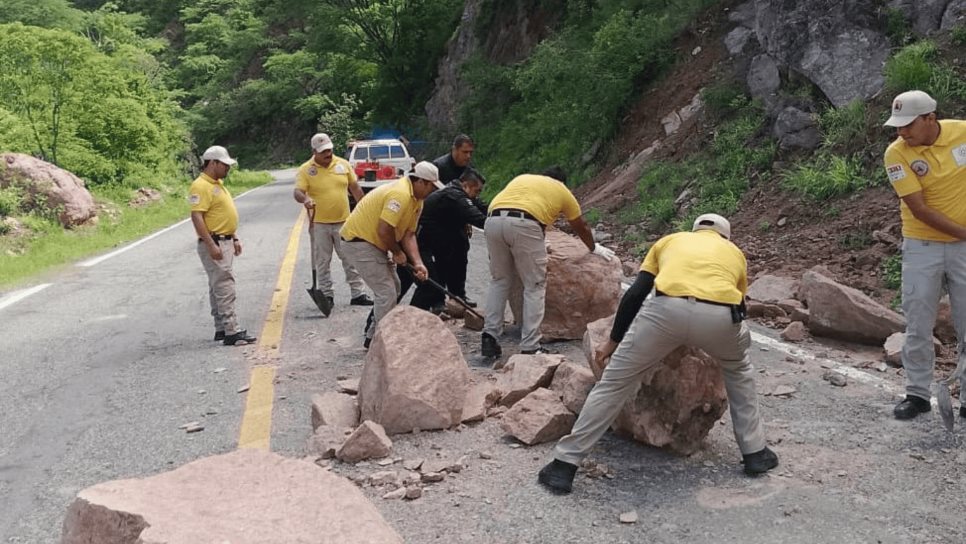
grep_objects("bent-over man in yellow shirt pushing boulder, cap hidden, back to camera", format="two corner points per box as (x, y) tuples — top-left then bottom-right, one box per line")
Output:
(481, 167), (614, 357)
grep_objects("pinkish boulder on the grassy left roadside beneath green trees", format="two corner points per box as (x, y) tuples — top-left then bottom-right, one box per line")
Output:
(0, 153), (97, 228)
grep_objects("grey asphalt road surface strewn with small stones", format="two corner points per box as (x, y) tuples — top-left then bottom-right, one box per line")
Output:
(0, 168), (966, 544)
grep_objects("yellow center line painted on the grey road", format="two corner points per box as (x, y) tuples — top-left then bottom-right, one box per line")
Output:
(238, 213), (305, 450)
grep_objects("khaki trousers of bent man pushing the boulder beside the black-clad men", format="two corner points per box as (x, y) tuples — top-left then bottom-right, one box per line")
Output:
(483, 216), (547, 350)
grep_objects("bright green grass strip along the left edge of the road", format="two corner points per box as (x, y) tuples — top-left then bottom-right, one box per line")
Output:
(0, 171), (272, 287)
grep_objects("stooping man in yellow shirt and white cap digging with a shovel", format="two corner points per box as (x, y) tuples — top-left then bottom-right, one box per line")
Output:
(341, 161), (443, 349)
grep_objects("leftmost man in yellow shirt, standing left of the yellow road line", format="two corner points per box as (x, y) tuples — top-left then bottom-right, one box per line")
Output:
(188, 145), (255, 346)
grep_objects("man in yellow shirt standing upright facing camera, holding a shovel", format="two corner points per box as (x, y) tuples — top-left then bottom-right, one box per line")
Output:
(293, 133), (372, 308)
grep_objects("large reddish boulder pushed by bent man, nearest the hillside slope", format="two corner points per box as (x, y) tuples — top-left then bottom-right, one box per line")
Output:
(540, 230), (623, 340)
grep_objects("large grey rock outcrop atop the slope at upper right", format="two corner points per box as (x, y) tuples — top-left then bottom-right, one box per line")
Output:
(755, 0), (889, 107)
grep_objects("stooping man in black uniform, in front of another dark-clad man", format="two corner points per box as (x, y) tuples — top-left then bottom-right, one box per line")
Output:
(397, 167), (486, 313)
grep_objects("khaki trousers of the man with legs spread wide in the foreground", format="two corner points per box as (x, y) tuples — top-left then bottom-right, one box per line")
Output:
(554, 297), (766, 465)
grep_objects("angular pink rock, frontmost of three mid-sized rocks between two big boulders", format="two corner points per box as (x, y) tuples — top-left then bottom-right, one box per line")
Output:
(500, 388), (577, 446)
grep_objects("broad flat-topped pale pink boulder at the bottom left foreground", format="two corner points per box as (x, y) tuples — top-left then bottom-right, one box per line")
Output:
(61, 449), (403, 544)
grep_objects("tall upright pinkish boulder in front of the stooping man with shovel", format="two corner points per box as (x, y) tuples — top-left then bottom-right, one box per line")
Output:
(359, 305), (470, 434)
